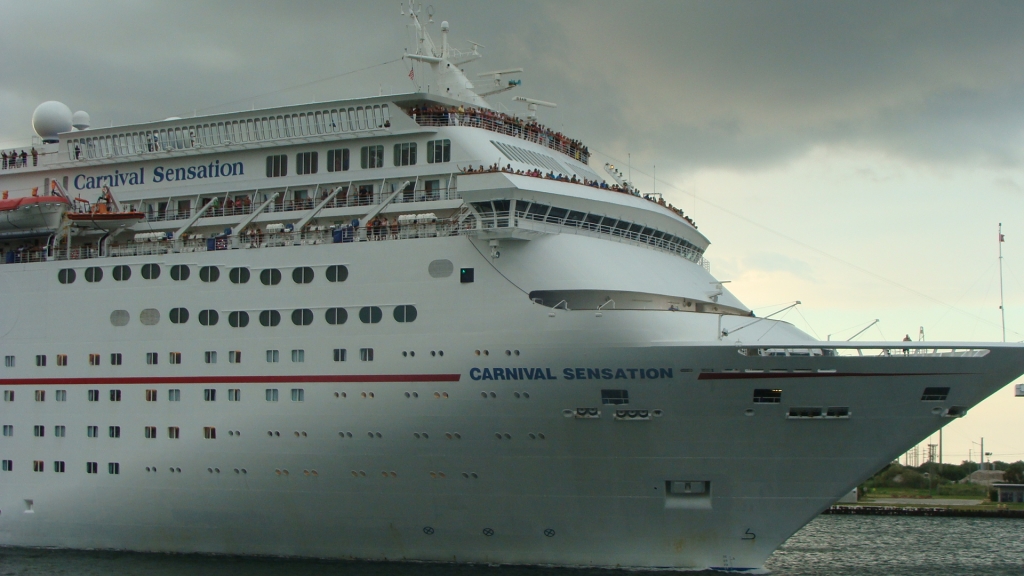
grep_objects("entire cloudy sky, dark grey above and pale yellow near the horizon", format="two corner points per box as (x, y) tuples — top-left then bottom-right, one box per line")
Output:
(0, 0), (1024, 462)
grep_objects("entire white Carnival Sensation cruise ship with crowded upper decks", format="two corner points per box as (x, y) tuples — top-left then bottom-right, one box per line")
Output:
(0, 8), (1024, 571)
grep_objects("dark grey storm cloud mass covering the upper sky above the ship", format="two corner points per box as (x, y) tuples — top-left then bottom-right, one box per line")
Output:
(0, 0), (1024, 168)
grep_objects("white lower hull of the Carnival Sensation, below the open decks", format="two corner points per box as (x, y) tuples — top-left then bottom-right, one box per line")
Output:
(0, 230), (1021, 569)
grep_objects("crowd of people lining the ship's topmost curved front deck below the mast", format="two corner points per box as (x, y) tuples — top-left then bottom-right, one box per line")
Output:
(409, 105), (590, 164)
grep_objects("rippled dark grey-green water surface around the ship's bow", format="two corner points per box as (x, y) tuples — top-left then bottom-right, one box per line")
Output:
(0, 516), (1024, 576)
